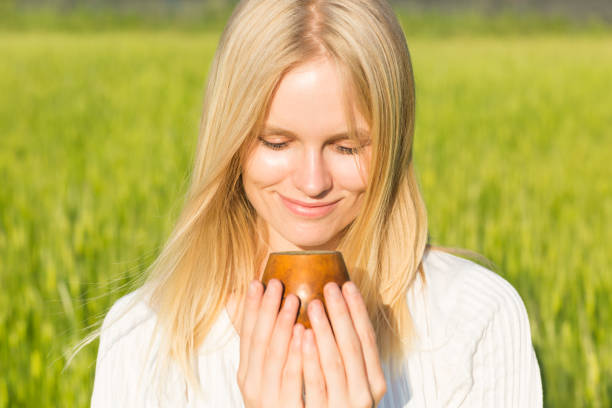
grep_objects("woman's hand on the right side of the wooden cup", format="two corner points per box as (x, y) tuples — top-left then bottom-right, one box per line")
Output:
(302, 281), (387, 408)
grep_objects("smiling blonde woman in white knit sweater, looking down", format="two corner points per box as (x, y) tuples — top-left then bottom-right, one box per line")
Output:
(79, 0), (542, 407)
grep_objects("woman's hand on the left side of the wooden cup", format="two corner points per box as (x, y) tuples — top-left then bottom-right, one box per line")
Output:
(237, 279), (304, 408)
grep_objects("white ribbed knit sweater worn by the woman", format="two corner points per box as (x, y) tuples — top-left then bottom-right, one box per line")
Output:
(91, 251), (542, 408)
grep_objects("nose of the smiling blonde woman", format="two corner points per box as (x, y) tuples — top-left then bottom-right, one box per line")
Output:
(293, 149), (332, 198)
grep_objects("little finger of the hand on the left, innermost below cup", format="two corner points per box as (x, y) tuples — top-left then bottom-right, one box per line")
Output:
(281, 323), (304, 407)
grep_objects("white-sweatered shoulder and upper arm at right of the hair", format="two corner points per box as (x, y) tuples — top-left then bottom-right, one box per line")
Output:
(408, 250), (541, 406)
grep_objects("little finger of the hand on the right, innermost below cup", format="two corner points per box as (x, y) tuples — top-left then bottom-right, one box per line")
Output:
(302, 329), (327, 408)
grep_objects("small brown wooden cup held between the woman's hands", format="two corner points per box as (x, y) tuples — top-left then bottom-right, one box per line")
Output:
(262, 251), (350, 328)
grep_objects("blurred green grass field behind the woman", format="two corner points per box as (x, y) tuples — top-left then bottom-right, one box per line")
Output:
(0, 0), (612, 407)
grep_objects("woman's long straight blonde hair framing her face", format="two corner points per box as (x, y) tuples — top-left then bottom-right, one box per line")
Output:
(70, 0), (492, 398)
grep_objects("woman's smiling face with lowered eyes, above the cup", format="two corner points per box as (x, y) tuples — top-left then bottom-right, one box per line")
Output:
(242, 55), (371, 251)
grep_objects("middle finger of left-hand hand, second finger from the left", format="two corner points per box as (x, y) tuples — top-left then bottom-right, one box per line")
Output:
(246, 279), (283, 392)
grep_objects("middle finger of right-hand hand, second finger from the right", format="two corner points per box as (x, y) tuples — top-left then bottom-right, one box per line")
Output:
(323, 282), (372, 406)
